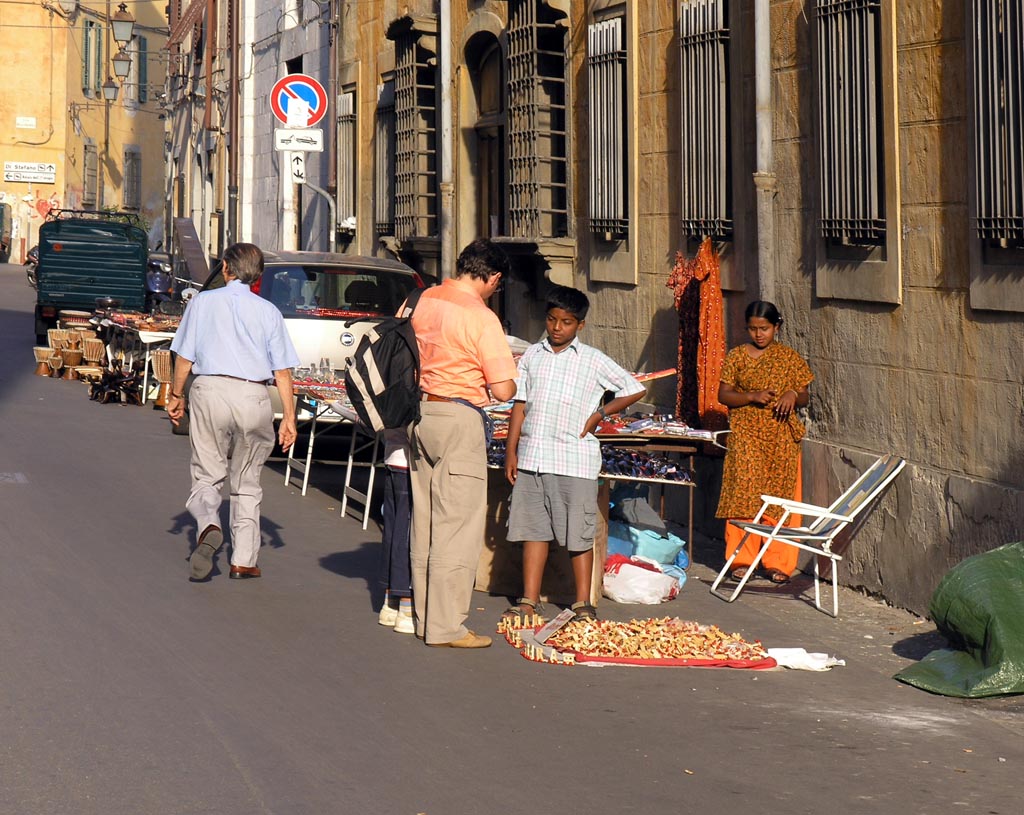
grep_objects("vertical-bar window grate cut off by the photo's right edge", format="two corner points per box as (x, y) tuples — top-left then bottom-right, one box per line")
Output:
(973, 0), (1024, 243)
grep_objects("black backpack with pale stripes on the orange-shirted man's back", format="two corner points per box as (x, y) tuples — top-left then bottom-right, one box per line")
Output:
(345, 289), (423, 430)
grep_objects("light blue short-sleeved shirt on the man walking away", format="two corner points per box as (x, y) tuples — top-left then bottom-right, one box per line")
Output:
(171, 281), (299, 382)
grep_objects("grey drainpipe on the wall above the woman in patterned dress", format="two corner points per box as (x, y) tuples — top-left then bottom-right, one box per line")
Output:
(754, 0), (777, 300)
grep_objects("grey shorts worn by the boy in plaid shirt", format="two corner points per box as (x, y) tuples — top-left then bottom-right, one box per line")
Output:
(507, 470), (597, 552)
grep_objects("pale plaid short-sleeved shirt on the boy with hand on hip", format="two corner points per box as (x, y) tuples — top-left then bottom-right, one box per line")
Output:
(515, 338), (644, 478)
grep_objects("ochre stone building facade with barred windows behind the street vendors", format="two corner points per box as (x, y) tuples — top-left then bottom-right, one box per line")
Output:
(329, 0), (1024, 610)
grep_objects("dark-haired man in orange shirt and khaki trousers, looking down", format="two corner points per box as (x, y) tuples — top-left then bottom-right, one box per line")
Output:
(411, 238), (517, 648)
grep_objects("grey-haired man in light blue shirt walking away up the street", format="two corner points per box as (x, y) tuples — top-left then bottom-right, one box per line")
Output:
(167, 244), (299, 581)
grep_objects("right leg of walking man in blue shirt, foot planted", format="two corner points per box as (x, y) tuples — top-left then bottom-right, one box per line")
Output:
(228, 380), (274, 565)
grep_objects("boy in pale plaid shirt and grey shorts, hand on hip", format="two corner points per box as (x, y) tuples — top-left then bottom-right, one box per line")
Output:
(505, 286), (645, 619)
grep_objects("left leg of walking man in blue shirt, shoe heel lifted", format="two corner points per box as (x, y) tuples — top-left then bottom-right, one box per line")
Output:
(185, 377), (233, 580)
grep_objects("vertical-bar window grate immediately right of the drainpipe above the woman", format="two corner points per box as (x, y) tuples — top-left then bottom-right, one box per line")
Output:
(816, 0), (886, 246)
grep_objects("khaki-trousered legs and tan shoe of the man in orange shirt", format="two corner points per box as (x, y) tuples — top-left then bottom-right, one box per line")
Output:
(413, 402), (490, 647)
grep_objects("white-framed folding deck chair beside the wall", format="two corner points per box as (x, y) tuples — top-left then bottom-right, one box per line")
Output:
(711, 456), (906, 617)
